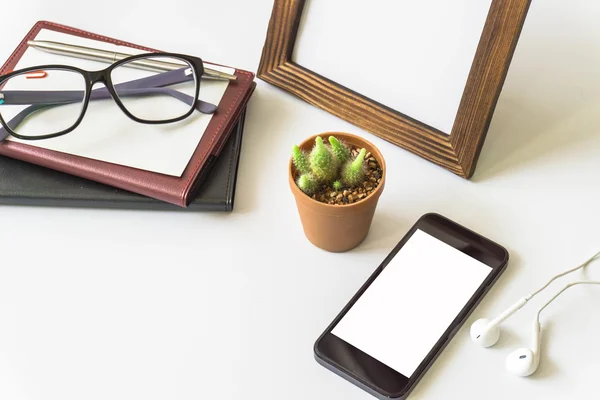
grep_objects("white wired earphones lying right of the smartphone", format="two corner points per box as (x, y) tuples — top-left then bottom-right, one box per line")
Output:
(470, 252), (600, 376)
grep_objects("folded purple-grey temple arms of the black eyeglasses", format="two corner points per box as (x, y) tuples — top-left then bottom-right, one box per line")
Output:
(0, 70), (217, 114)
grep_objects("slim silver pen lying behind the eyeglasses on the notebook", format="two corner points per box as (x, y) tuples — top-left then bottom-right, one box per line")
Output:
(27, 40), (237, 81)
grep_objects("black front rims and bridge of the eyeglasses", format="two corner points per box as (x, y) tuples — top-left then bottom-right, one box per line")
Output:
(0, 52), (204, 140)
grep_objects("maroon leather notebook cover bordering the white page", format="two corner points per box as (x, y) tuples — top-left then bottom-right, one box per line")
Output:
(0, 21), (256, 207)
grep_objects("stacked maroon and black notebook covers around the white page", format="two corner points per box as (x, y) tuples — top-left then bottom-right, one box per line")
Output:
(0, 22), (256, 211)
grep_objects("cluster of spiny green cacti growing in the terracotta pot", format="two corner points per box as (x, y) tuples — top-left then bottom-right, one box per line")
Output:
(292, 136), (367, 195)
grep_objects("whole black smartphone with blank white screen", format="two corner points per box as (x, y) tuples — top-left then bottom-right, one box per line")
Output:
(314, 214), (509, 399)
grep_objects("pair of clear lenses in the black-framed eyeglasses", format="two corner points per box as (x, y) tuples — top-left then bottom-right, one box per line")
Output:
(0, 55), (199, 138)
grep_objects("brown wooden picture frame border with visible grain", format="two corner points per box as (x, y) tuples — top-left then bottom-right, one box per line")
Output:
(257, 0), (531, 179)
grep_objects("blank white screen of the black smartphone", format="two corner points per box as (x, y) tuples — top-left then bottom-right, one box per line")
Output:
(331, 230), (492, 377)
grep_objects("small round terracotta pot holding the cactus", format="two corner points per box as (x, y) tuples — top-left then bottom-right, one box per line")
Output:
(288, 132), (386, 252)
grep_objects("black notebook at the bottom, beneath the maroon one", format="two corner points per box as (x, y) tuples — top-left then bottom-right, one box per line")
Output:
(0, 110), (246, 211)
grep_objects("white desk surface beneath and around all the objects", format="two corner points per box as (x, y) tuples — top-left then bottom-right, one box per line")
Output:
(0, 0), (600, 400)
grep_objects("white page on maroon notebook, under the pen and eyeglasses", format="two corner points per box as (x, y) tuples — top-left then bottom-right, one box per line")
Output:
(4, 29), (235, 176)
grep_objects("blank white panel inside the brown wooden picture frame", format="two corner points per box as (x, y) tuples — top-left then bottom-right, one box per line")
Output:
(294, 0), (492, 134)
